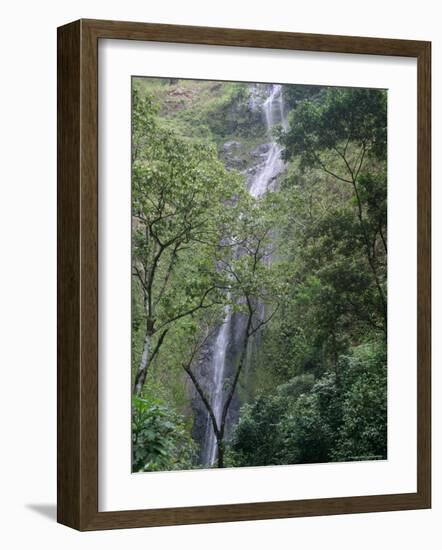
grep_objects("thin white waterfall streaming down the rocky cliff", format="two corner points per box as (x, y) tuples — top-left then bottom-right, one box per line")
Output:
(202, 84), (286, 466)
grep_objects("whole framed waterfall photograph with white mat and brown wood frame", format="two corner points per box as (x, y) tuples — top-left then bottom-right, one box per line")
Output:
(58, 20), (431, 530)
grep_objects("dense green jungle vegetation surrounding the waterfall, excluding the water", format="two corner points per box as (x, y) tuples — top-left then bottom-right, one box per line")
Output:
(132, 78), (387, 471)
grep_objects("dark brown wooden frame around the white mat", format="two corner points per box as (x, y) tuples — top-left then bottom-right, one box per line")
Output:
(57, 20), (431, 531)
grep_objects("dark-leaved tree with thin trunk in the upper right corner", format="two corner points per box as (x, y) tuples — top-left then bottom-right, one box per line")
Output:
(280, 88), (387, 333)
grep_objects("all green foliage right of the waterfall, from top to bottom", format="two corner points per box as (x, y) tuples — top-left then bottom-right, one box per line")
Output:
(233, 88), (387, 465)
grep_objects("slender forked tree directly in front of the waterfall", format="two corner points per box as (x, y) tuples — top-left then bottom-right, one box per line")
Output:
(183, 196), (285, 468)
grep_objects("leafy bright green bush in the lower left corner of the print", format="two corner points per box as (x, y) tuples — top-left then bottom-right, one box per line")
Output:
(132, 397), (196, 472)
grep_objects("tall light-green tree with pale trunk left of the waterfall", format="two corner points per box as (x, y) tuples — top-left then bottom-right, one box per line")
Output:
(132, 90), (242, 395)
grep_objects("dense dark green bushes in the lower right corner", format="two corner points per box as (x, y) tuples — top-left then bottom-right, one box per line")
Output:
(229, 344), (387, 466)
